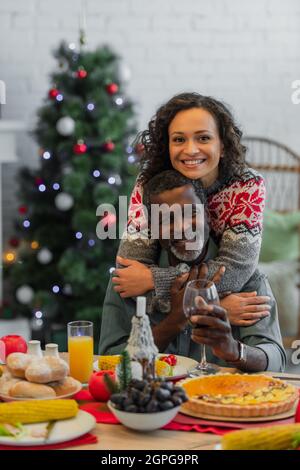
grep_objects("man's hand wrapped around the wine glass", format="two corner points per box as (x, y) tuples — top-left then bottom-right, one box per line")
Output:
(190, 297), (239, 362)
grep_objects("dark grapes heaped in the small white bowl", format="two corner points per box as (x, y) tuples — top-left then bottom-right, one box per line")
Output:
(110, 379), (188, 413)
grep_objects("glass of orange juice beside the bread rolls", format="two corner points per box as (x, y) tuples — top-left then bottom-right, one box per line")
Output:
(68, 321), (94, 384)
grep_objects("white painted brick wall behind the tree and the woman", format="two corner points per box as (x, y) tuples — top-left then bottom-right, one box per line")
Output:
(0, 0), (300, 241)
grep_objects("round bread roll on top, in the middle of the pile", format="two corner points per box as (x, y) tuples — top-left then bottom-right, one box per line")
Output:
(25, 356), (69, 384)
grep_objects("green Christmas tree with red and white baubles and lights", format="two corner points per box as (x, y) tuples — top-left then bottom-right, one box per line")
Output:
(2, 37), (138, 341)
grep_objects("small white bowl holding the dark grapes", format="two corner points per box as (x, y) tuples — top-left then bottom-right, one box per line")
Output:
(107, 401), (180, 431)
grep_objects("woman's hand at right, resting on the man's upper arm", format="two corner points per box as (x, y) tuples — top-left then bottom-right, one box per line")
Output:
(220, 292), (271, 326)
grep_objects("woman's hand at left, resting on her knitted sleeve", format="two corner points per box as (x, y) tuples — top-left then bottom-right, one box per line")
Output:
(112, 256), (154, 298)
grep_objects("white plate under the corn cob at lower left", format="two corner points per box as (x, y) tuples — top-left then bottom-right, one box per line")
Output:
(0, 410), (96, 446)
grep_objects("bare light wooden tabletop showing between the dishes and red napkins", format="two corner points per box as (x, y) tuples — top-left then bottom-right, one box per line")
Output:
(63, 368), (300, 451)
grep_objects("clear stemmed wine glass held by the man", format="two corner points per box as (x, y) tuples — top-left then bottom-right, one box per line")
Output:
(183, 279), (220, 376)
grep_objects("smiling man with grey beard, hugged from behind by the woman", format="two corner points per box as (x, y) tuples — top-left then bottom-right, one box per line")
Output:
(99, 170), (285, 371)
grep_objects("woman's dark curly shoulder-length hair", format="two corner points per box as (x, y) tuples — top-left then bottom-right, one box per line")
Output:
(136, 93), (246, 184)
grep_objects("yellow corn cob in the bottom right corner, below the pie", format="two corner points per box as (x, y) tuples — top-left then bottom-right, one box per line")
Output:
(222, 424), (300, 450)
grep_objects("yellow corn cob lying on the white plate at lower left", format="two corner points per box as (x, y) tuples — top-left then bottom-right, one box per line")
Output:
(0, 399), (78, 424)
